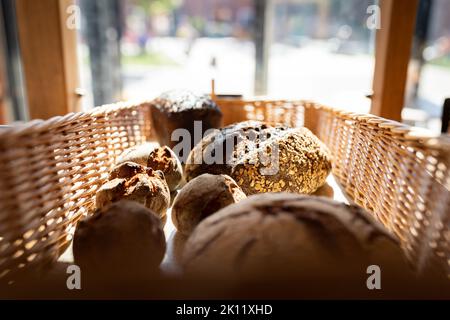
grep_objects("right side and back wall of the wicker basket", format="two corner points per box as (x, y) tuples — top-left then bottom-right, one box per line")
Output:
(218, 100), (450, 277)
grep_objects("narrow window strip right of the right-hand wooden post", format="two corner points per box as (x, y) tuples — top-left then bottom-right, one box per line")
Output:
(403, 0), (450, 133)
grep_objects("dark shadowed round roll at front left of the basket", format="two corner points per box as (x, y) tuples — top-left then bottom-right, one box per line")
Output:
(73, 201), (166, 279)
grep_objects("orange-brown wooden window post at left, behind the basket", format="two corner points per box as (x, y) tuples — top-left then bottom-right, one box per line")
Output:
(16, 0), (80, 119)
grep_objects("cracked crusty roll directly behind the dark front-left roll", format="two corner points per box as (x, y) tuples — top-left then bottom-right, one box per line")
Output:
(95, 168), (170, 223)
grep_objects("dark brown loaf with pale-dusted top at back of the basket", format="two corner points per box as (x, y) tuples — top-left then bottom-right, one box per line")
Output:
(151, 90), (222, 163)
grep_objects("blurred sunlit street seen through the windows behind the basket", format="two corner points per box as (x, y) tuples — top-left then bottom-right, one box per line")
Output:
(75, 0), (450, 131)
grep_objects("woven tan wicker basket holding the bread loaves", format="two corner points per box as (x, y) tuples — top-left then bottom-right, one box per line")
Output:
(0, 99), (450, 281)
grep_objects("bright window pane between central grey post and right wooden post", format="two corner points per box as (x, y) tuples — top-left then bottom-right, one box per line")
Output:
(269, 0), (374, 111)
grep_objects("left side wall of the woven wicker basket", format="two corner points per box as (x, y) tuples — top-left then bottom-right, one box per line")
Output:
(0, 103), (150, 279)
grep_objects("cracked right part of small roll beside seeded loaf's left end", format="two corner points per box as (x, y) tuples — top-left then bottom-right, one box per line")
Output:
(147, 146), (183, 191)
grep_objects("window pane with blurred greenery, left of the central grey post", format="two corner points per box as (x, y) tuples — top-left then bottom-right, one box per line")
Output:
(121, 0), (254, 98)
